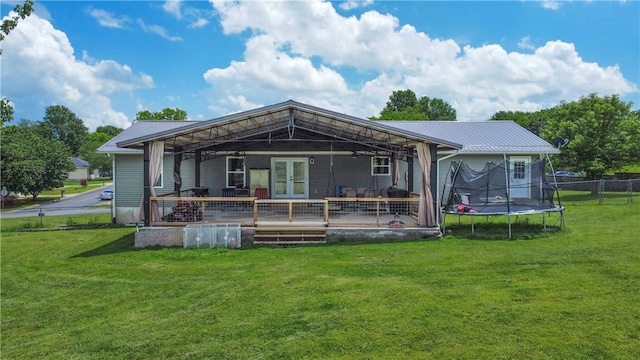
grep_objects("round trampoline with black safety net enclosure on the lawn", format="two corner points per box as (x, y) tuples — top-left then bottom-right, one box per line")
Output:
(442, 155), (564, 239)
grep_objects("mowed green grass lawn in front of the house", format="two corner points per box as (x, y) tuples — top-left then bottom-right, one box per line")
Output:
(1, 194), (640, 359)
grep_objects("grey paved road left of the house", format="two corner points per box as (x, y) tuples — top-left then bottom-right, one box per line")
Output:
(0, 185), (113, 219)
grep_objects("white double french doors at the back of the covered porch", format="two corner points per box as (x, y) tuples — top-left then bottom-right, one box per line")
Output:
(271, 158), (309, 199)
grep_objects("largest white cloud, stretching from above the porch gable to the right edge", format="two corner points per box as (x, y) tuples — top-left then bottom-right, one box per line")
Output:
(204, 1), (638, 120)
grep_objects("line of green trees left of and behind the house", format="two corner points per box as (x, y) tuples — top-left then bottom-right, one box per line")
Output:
(0, 103), (187, 200)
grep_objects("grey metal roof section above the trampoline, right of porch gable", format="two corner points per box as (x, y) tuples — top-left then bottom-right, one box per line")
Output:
(380, 120), (560, 154)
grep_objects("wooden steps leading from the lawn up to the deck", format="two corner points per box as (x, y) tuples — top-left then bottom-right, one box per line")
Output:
(253, 226), (327, 245)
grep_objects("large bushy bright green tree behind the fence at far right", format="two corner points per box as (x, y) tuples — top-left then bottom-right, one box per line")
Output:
(540, 94), (640, 179)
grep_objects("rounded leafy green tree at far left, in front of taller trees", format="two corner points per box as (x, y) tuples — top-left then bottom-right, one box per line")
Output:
(0, 125), (75, 200)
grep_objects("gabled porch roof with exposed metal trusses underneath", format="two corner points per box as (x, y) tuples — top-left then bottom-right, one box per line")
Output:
(117, 101), (462, 154)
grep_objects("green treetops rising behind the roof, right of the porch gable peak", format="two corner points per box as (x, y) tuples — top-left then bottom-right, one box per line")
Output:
(369, 90), (456, 120)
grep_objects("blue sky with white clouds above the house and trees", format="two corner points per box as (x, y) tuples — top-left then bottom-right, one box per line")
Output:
(0, 0), (640, 131)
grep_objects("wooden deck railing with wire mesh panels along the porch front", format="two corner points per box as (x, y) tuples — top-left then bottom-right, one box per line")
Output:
(149, 194), (419, 227)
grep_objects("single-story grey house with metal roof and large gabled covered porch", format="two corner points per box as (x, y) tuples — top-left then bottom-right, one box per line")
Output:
(98, 101), (554, 246)
